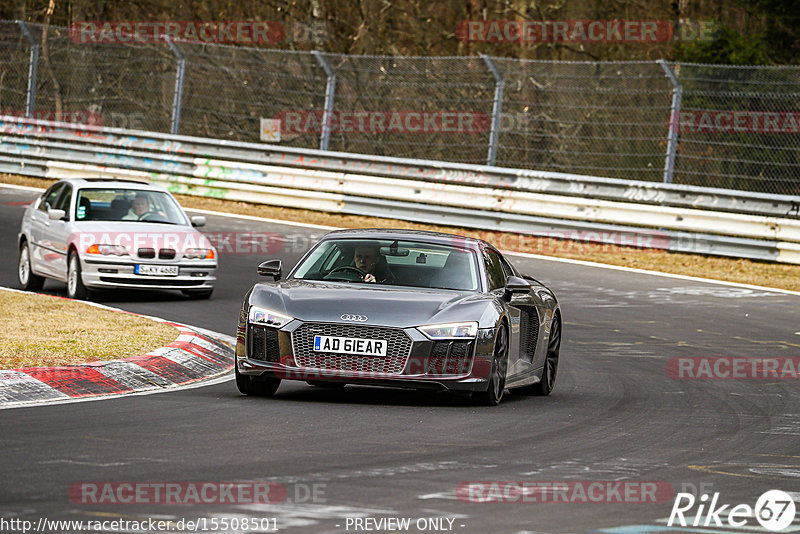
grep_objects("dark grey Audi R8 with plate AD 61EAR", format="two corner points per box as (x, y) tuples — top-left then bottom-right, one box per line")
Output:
(235, 229), (562, 405)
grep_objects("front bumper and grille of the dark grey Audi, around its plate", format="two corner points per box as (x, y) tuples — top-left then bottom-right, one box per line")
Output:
(236, 316), (494, 392)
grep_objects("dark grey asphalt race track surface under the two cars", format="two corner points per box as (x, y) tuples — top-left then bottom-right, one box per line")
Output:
(0, 188), (800, 533)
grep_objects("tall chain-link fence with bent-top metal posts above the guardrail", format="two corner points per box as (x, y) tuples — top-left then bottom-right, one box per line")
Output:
(0, 21), (800, 194)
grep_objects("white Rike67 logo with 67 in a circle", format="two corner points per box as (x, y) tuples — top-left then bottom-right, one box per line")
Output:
(667, 490), (795, 532)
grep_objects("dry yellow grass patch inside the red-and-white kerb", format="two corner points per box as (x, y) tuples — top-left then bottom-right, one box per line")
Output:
(0, 291), (180, 370)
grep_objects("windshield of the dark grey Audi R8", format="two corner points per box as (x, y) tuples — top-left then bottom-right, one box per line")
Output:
(292, 239), (479, 291)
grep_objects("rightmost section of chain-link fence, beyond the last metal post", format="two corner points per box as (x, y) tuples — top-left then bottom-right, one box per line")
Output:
(672, 65), (800, 194)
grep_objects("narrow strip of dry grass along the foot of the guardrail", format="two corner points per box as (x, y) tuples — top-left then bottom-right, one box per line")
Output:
(0, 174), (800, 291)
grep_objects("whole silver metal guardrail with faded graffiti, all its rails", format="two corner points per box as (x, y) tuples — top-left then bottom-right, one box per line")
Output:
(0, 117), (800, 263)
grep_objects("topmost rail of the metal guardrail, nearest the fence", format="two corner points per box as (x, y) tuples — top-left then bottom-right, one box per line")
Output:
(0, 116), (800, 217)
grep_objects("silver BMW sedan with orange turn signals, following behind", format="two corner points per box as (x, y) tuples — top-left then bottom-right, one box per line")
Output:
(17, 178), (217, 299)
